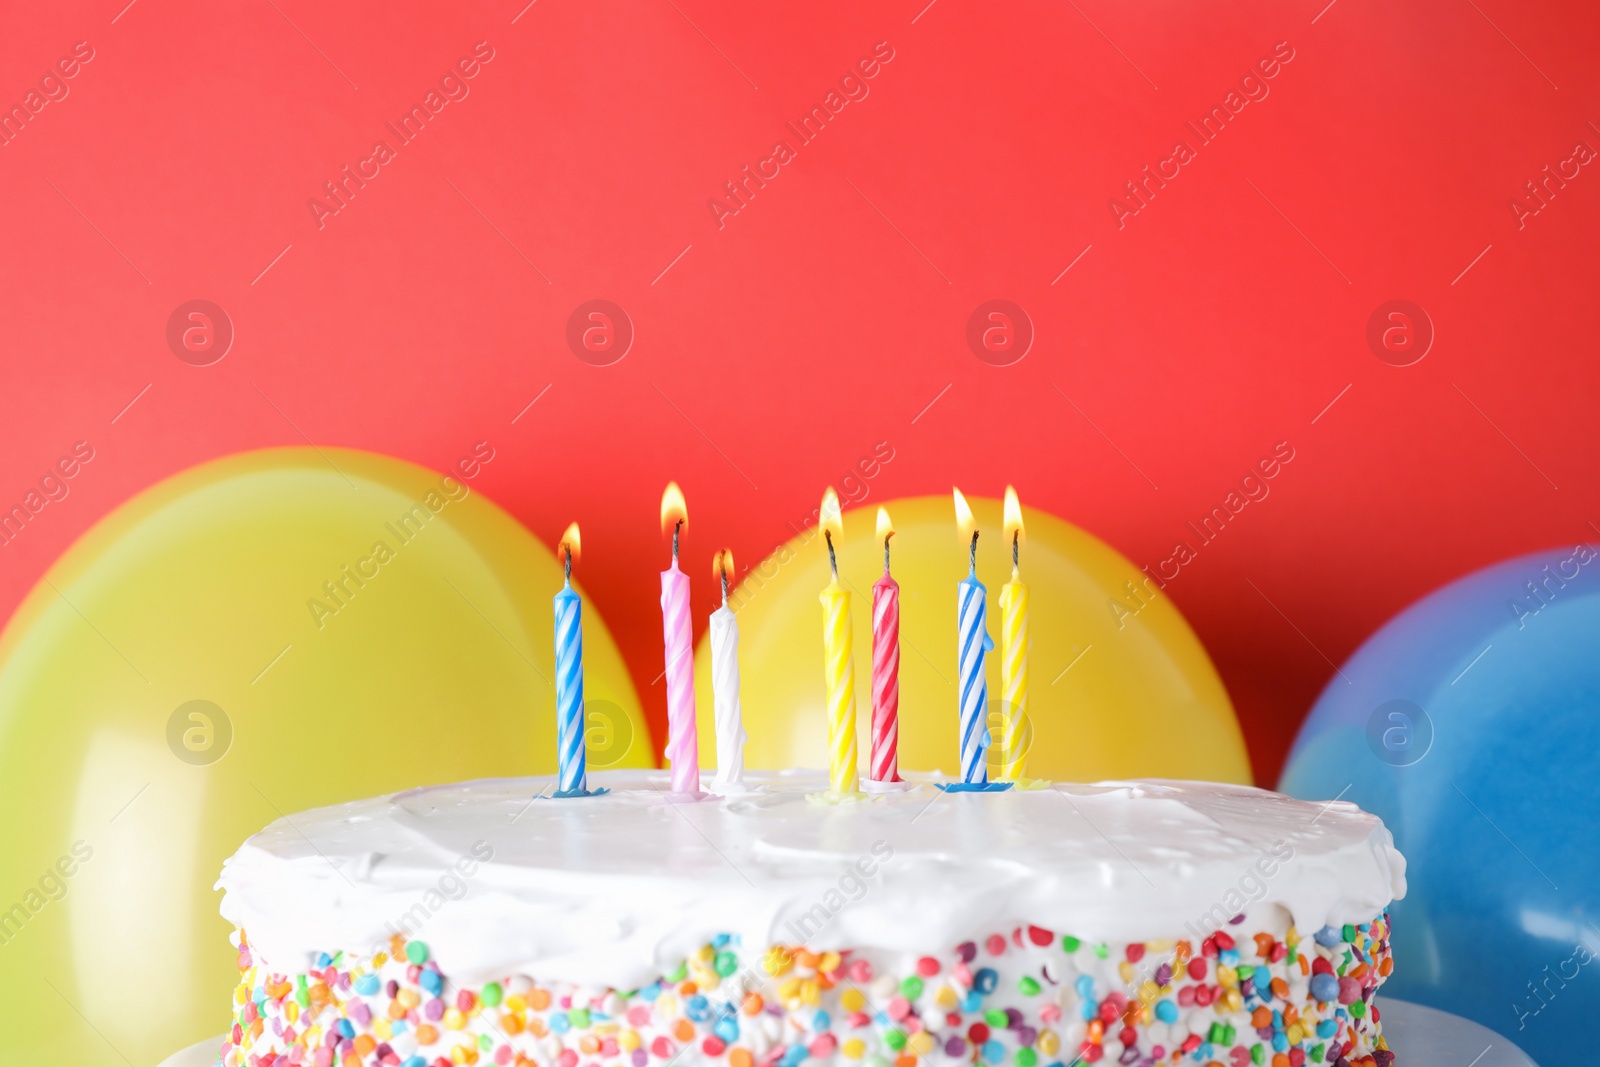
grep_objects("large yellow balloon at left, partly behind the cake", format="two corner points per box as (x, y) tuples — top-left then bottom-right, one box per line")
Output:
(0, 448), (654, 1064)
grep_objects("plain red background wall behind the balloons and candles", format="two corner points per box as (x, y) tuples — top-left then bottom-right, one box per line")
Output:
(0, 0), (1600, 784)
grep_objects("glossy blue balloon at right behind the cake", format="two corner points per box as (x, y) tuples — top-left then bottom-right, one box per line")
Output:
(1278, 545), (1600, 1064)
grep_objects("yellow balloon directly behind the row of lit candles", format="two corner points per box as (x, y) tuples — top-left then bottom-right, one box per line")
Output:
(696, 496), (1251, 782)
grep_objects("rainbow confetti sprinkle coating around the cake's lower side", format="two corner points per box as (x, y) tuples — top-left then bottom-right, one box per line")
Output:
(221, 913), (1394, 1067)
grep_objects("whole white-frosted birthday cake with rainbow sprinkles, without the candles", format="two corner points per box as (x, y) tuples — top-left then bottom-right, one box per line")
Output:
(209, 771), (1405, 1067)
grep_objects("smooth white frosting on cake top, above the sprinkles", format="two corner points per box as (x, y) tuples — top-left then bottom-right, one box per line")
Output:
(218, 771), (1405, 989)
